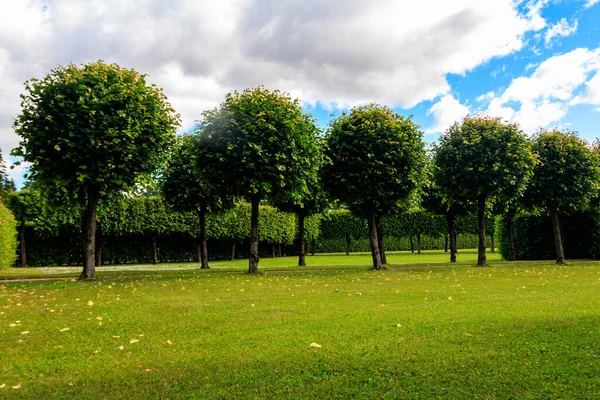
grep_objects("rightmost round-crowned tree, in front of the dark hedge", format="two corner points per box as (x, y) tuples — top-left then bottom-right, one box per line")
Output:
(525, 130), (599, 264)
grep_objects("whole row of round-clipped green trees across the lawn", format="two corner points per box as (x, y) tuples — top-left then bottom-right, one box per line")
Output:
(7, 61), (598, 279)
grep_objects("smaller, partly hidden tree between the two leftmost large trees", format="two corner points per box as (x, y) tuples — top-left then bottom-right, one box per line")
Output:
(162, 135), (232, 269)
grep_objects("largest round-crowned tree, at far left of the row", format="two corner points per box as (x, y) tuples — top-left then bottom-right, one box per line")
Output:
(12, 61), (179, 279)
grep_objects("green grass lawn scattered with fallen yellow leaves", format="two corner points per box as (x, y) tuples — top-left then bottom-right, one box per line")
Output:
(0, 252), (600, 399)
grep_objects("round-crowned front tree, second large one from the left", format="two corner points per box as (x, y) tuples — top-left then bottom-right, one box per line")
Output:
(198, 87), (318, 274)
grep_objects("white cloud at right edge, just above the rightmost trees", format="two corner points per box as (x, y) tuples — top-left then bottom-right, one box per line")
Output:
(486, 48), (600, 133)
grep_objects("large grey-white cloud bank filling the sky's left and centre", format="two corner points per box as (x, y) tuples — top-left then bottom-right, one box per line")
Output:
(0, 0), (546, 158)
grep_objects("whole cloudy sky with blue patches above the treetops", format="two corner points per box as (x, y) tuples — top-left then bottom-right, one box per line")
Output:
(0, 0), (600, 186)
